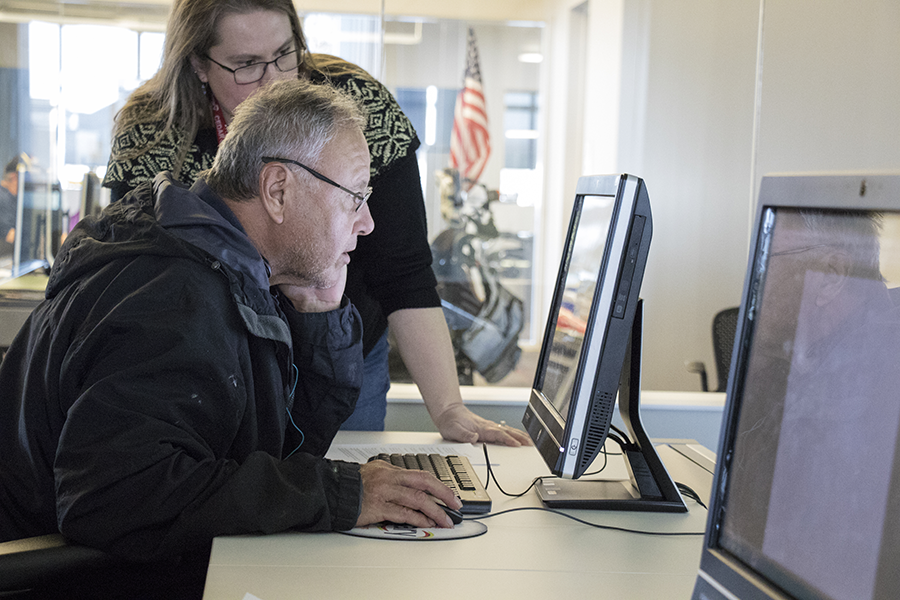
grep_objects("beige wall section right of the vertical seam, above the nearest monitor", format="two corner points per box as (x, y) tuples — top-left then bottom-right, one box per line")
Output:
(757, 0), (900, 193)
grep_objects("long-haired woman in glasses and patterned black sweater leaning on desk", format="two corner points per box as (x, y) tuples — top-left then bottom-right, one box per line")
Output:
(103, 0), (530, 446)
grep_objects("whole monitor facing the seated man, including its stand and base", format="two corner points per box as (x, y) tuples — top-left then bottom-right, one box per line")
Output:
(522, 174), (687, 512)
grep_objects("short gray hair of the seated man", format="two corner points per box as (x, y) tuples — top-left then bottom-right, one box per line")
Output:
(205, 79), (366, 202)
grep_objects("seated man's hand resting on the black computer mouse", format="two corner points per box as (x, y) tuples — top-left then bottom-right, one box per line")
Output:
(356, 460), (462, 527)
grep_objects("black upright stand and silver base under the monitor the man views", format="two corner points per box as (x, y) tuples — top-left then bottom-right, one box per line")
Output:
(535, 300), (687, 512)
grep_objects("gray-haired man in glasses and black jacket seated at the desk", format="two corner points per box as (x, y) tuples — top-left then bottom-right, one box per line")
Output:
(0, 80), (460, 598)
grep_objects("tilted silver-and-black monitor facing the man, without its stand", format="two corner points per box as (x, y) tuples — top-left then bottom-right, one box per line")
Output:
(523, 175), (652, 478)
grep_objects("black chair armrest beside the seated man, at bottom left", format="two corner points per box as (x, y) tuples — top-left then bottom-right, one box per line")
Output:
(0, 534), (119, 600)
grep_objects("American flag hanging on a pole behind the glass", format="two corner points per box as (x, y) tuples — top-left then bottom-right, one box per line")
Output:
(450, 27), (491, 189)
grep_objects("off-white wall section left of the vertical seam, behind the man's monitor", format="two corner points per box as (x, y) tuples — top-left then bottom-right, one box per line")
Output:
(619, 0), (759, 390)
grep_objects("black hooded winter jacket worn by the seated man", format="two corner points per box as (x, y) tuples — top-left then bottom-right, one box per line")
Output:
(0, 173), (362, 561)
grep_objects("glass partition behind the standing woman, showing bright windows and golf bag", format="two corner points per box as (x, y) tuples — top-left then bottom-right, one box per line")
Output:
(0, 9), (543, 386)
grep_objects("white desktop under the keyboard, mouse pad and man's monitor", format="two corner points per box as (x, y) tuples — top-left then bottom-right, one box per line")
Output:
(204, 432), (712, 600)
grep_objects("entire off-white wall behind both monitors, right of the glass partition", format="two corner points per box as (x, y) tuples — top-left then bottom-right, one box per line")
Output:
(544, 0), (900, 390)
